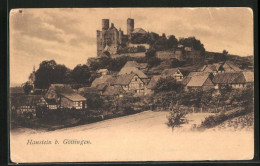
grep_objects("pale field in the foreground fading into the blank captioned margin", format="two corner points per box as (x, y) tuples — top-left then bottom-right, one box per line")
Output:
(10, 111), (254, 163)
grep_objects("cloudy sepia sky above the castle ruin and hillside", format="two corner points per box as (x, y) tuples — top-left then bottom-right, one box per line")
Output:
(9, 7), (254, 86)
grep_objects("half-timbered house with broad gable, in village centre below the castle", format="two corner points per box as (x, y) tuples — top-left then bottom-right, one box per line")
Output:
(113, 73), (145, 95)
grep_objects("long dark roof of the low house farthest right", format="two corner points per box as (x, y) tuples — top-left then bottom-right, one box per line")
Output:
(212, 72), (246, 84)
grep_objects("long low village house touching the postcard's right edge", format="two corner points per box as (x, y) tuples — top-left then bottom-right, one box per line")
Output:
(212, 72), (254, 89)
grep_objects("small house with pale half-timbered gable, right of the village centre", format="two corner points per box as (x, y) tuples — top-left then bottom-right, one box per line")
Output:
(161, 68), (187, 81)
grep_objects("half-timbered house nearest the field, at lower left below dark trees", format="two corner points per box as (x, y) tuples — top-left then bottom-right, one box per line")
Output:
(44, 84), (87, 109)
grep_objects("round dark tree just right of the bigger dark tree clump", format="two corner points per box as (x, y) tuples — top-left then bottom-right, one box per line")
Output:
(71, 65), (91, 84)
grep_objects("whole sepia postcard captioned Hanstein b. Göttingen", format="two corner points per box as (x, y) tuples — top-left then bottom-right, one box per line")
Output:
(9, 7), (254, 163)
